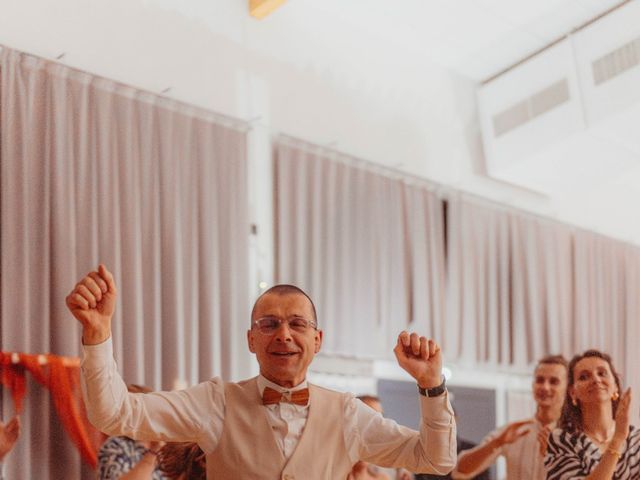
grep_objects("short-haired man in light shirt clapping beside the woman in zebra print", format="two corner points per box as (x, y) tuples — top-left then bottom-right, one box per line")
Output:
(451, 355), (567, 480)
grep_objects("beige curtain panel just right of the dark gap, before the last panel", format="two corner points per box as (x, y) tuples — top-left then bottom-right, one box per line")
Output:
(446, 196), (573, 367)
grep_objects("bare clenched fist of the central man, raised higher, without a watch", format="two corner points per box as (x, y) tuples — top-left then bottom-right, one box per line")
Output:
(66, 264), (117, 345)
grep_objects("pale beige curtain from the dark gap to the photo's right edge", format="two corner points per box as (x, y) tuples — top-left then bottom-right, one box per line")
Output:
(446, 195), (640, 390)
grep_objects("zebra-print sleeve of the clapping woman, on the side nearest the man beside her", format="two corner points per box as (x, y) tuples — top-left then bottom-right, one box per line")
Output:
(544, 429), (595, 480)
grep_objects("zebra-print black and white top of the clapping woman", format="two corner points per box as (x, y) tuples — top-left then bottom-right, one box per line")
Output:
(544, 426), (640, 480)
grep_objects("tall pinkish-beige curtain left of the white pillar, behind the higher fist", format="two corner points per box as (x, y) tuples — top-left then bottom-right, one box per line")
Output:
(0, 48), (249, 479)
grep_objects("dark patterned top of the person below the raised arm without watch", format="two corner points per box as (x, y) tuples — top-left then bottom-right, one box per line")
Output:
(98, 437), (167, 480)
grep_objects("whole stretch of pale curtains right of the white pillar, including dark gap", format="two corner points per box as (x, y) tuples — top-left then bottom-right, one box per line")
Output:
(274, 137), (640, 404)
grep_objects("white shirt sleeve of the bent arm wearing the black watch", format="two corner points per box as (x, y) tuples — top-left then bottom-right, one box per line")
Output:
(344, 392), (456, 475)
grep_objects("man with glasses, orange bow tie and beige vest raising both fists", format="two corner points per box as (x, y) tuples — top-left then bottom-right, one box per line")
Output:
(67, 265), (455, 480)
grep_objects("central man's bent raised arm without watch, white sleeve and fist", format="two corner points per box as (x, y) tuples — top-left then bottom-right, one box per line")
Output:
(66, 265), (224, 451)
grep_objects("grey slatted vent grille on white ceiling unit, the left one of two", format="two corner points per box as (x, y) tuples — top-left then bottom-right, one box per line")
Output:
(492, 78), (569, 138)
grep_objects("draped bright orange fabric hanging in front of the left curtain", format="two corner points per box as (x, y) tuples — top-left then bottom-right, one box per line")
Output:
(0, 352), (101, 468)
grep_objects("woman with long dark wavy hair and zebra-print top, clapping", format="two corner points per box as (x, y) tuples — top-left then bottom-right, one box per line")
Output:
(545, 350), (640, 480)
